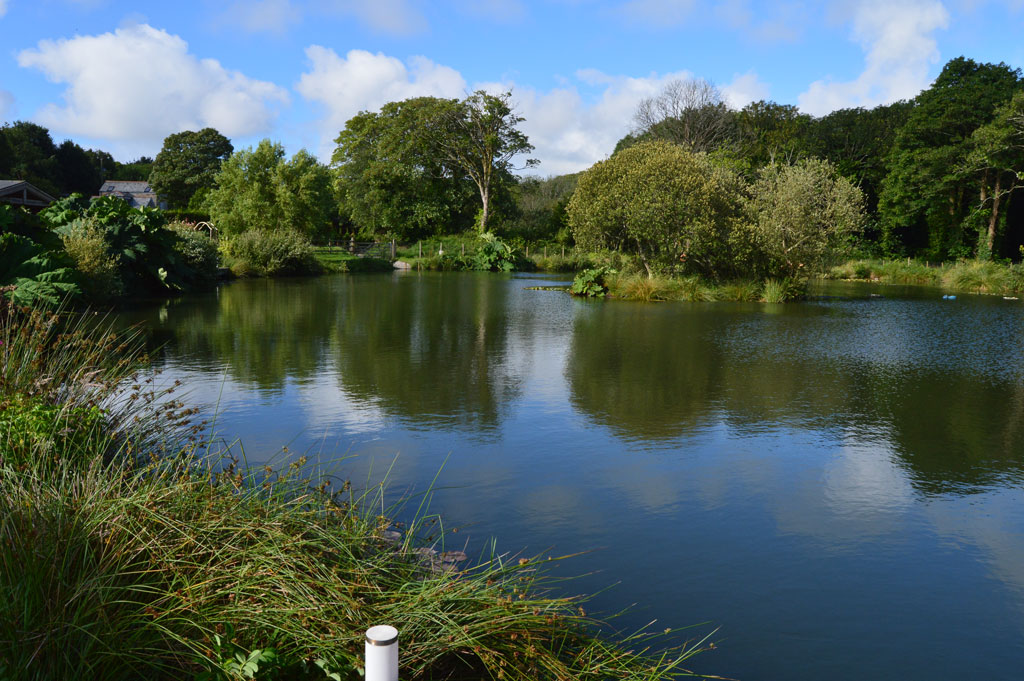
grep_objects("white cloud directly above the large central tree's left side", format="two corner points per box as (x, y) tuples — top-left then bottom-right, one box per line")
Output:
(295, 45), (466, 159)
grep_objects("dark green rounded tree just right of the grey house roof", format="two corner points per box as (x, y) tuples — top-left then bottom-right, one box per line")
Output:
(150, 128), (234, 208)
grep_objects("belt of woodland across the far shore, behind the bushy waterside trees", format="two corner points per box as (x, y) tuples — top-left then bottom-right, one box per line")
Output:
(0, 57), (1024, 261)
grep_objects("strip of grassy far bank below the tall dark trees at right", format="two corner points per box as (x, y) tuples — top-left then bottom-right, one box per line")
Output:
(827, 260), (1024, 295)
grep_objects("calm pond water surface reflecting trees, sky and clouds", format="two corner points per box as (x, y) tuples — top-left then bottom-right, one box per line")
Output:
(116, 273), (1024, 681)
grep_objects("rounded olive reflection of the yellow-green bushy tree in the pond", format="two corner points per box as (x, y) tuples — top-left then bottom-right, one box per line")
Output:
(565, 303), (723, 439)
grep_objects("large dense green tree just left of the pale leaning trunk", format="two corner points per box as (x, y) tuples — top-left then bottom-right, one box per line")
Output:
(331, 97), (476, 239)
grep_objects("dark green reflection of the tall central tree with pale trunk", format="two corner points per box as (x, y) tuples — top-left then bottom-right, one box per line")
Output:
(332, 274), (519, 426)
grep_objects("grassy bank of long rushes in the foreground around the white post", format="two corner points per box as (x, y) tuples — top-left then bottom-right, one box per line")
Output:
(0, 301), (716, 680)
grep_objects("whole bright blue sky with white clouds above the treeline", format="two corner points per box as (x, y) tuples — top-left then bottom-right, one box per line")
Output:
(0, 0), (1024, 174)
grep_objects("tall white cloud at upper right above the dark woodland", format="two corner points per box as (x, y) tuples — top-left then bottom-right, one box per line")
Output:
(799, 0), (949, 115)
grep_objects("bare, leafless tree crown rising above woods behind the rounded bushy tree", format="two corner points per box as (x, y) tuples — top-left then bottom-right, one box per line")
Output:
(634, 79), (736, 152)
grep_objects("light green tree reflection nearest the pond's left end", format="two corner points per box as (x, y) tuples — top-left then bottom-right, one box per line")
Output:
(146, 279), (337, 390)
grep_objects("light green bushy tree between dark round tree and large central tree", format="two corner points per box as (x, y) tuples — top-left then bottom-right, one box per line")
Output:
(205, 139), (334, 237)
